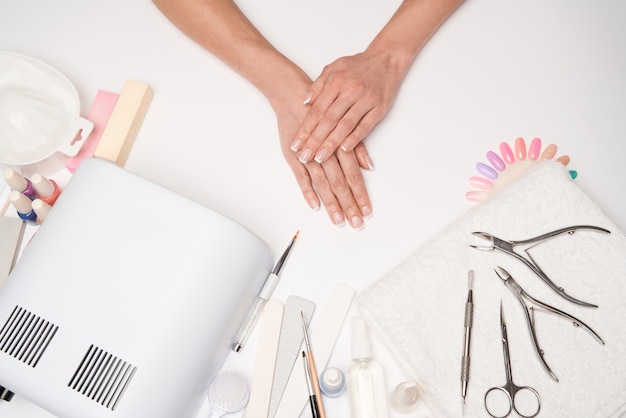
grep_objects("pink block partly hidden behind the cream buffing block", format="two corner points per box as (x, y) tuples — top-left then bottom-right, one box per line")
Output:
(65, 90), (119, 173)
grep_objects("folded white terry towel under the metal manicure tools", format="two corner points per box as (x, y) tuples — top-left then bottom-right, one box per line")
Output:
(356, 161), (626, 417)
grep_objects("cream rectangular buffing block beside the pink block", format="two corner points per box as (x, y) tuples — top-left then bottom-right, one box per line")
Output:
(94, 80), (154, 167)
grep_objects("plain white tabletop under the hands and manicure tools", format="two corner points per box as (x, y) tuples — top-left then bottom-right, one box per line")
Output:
(0, 0), (626, 418)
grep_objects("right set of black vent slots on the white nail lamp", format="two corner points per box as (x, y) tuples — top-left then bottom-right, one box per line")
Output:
(67, 344), (137, 411)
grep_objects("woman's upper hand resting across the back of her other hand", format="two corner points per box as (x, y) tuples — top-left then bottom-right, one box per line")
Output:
(290, 50), (406, 168)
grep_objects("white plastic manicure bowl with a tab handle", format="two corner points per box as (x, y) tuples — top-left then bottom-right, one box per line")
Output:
(0, 52), (93, 165)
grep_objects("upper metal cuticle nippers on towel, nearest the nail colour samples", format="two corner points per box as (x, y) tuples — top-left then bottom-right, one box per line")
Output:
(470, 225), (611, 308)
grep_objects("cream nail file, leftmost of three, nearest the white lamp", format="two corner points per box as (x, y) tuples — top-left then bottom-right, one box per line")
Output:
(243, 299), (284, 418)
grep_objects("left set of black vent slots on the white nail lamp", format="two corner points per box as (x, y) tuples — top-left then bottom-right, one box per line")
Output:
(0, 306), (59, 367)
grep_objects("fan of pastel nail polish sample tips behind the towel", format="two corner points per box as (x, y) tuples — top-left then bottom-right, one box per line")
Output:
(465, 137), (578, 202)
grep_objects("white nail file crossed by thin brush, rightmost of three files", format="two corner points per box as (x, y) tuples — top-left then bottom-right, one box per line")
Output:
(275, 285), (354, 418)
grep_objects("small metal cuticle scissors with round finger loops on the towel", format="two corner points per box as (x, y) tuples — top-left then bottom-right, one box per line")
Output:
(485, 301), (541, 418)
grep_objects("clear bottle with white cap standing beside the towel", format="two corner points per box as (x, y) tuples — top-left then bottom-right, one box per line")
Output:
(347, 316), (388, 418)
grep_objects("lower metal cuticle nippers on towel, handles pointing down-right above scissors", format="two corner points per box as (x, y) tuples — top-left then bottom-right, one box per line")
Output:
(495, 267), (604, 382)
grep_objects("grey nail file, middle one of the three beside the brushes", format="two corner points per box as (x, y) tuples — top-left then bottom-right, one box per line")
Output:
(267, 295), (315, 418)
